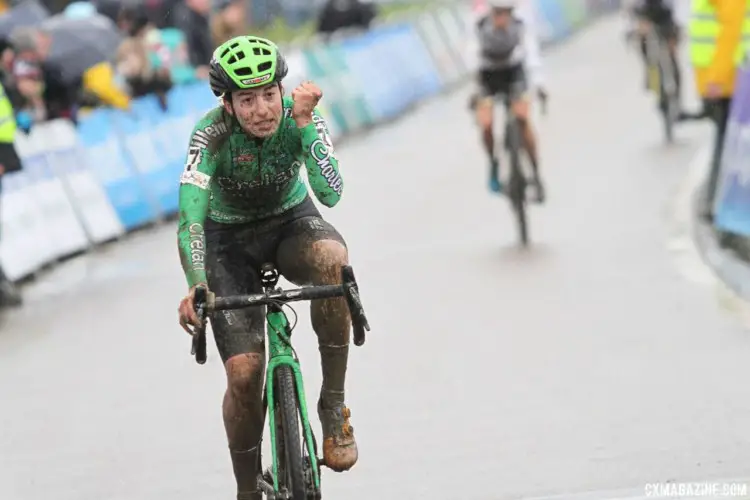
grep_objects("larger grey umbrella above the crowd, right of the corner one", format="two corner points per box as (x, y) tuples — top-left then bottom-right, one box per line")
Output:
(41, 15), (122, 82)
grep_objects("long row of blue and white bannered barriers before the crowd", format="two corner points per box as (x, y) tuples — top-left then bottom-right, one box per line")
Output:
(0, 0), (619, 281)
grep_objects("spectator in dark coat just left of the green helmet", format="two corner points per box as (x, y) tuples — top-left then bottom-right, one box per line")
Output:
(173, 0), (214, 79)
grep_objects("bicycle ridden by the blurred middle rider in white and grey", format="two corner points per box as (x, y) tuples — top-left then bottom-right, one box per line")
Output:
(493, 82), (547, 247)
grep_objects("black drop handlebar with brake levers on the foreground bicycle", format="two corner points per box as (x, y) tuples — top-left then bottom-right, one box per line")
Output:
(190, 266), (370, 365)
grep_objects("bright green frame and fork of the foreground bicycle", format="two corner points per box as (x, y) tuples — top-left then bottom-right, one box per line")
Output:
(266, 304), (320, 493)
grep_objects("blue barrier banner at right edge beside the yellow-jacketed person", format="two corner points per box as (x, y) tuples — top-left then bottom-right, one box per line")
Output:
(714, 58), (750, 237)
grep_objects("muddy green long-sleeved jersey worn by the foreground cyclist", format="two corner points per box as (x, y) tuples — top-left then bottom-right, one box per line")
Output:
(178, 97), (344, 287)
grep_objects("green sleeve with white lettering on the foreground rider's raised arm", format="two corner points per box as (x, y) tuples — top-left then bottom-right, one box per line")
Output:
(299, 109), (344, 207)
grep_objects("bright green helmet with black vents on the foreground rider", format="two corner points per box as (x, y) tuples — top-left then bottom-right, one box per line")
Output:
(209, 35), (289, 96)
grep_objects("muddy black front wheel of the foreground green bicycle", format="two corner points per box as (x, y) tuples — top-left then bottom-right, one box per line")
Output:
(275, 365), (307, 500)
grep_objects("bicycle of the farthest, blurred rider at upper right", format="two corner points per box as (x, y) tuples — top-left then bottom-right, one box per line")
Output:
(646, 23), (680, 143)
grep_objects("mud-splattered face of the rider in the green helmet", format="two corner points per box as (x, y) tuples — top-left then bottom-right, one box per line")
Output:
(224, 83), (283, 139)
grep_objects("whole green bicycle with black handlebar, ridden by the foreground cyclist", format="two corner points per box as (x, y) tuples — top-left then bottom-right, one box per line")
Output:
(191, 263), (370, 500)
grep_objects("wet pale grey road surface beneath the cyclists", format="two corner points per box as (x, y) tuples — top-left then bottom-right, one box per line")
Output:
(0, 13), (750, 500)
